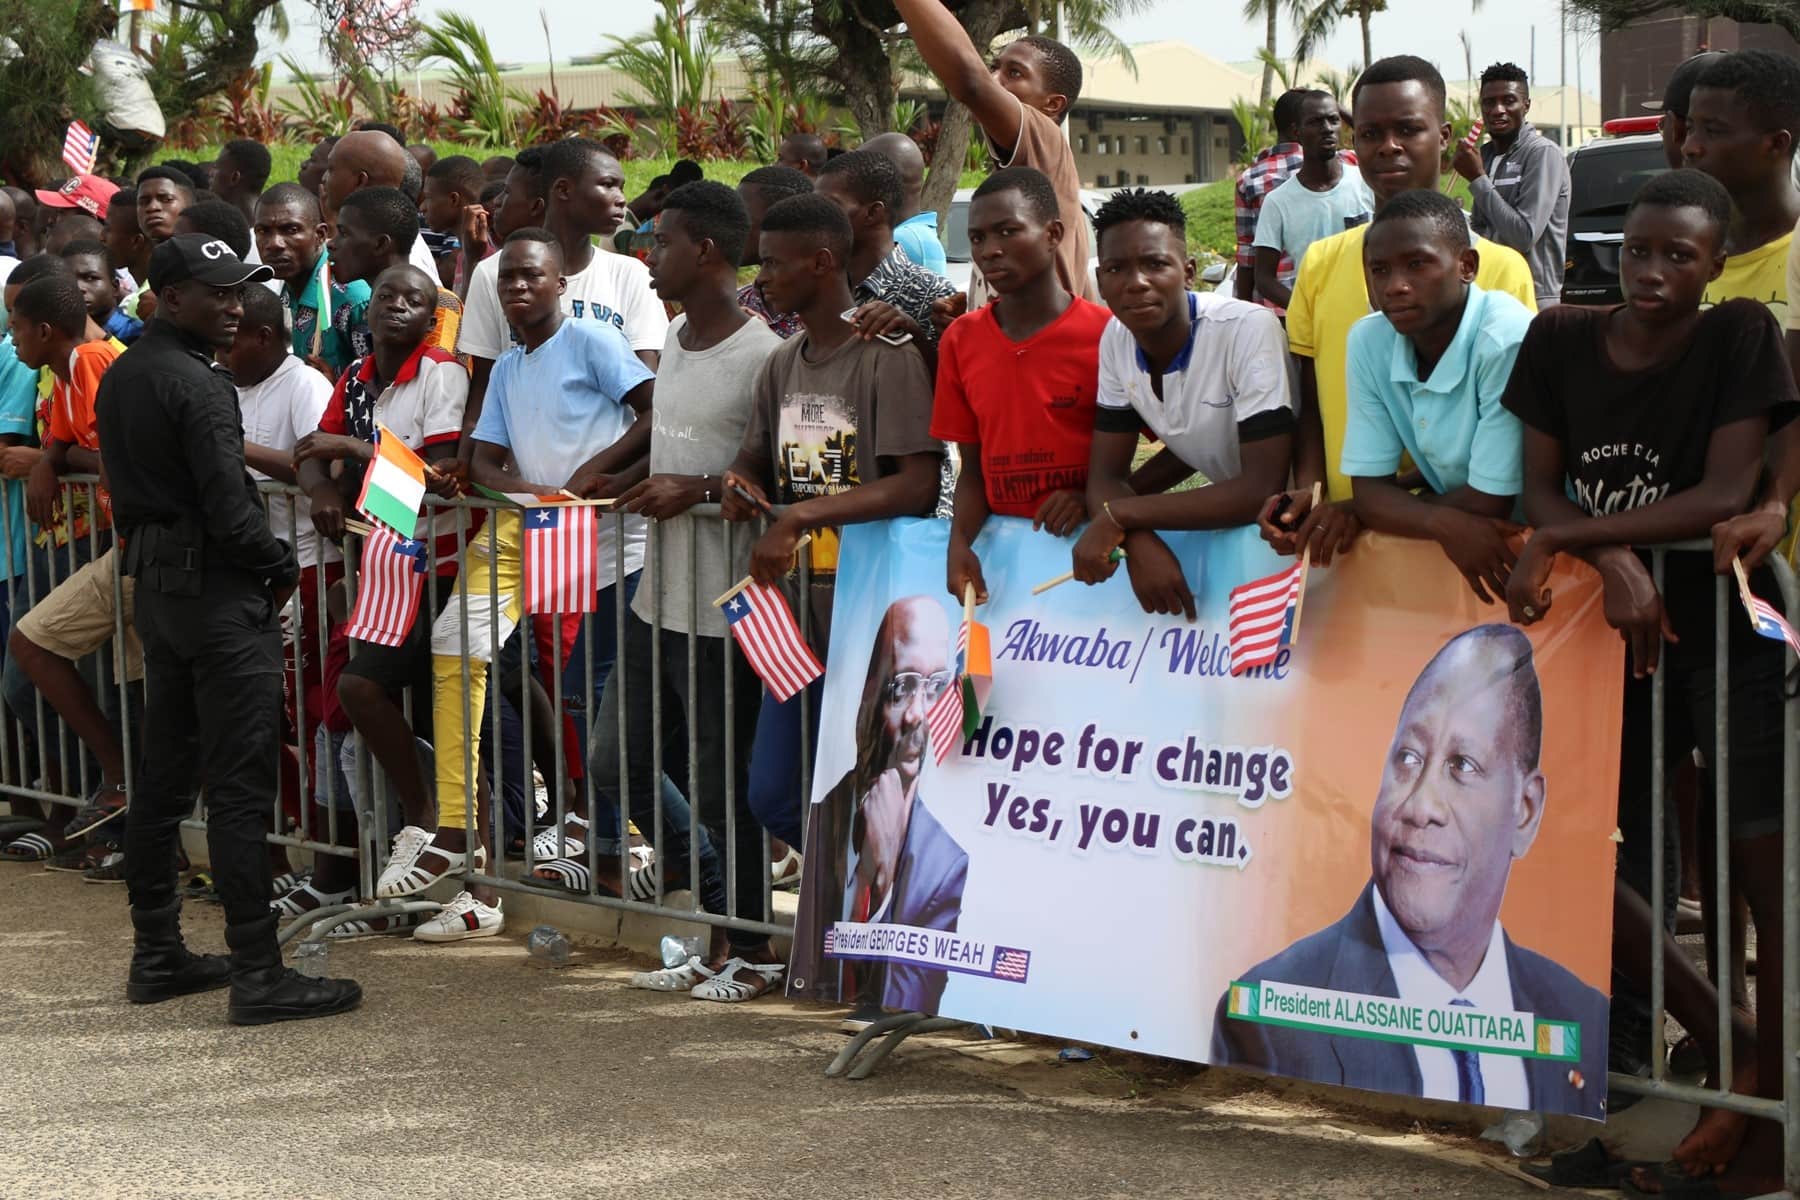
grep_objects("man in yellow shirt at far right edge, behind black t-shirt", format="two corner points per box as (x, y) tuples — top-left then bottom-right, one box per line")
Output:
(1681, 50), (1800, 570)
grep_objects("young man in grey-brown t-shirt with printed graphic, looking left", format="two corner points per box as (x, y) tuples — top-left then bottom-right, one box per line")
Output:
(722, 194), (943, 658)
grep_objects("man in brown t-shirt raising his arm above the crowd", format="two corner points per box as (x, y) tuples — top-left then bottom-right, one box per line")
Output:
(895, 0), (1100, 308)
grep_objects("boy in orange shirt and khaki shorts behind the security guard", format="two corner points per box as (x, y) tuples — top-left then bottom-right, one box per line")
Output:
(7, 275), (144, 867)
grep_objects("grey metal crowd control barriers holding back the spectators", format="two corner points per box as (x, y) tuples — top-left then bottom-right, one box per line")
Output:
(0, 479), (1800, 1189)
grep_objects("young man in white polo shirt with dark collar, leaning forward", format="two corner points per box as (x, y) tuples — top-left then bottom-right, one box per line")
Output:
(1075, 189), (1294, 621)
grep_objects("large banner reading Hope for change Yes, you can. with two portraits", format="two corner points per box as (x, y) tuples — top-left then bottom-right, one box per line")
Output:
(788, 518), (1624, 1119)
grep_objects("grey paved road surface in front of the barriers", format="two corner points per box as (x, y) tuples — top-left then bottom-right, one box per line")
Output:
(0, 864), (1535, 1200)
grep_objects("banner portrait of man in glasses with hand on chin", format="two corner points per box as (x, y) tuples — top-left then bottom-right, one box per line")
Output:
(790, 596), (968, 1013)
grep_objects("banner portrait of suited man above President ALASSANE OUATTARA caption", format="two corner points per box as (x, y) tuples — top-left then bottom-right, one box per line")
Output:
(1211, 624), (1607, 1117)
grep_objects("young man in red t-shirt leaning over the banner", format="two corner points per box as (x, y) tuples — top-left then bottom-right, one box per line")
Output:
(931, 167), (1111, 603)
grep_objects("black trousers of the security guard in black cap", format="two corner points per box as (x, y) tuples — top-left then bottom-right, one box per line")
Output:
(126, 569), (281, 925)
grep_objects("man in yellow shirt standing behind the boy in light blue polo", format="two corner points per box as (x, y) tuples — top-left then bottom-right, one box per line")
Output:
(1262, 54), (1537, 565)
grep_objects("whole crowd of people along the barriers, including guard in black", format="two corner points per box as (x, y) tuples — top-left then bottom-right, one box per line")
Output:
(0, 0), (1800, 1191)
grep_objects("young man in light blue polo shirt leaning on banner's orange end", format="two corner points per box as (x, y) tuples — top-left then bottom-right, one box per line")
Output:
(1339, 191), (1532, 603)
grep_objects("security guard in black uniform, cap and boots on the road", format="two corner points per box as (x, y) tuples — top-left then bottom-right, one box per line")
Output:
(95, 234), (362, 1025)
